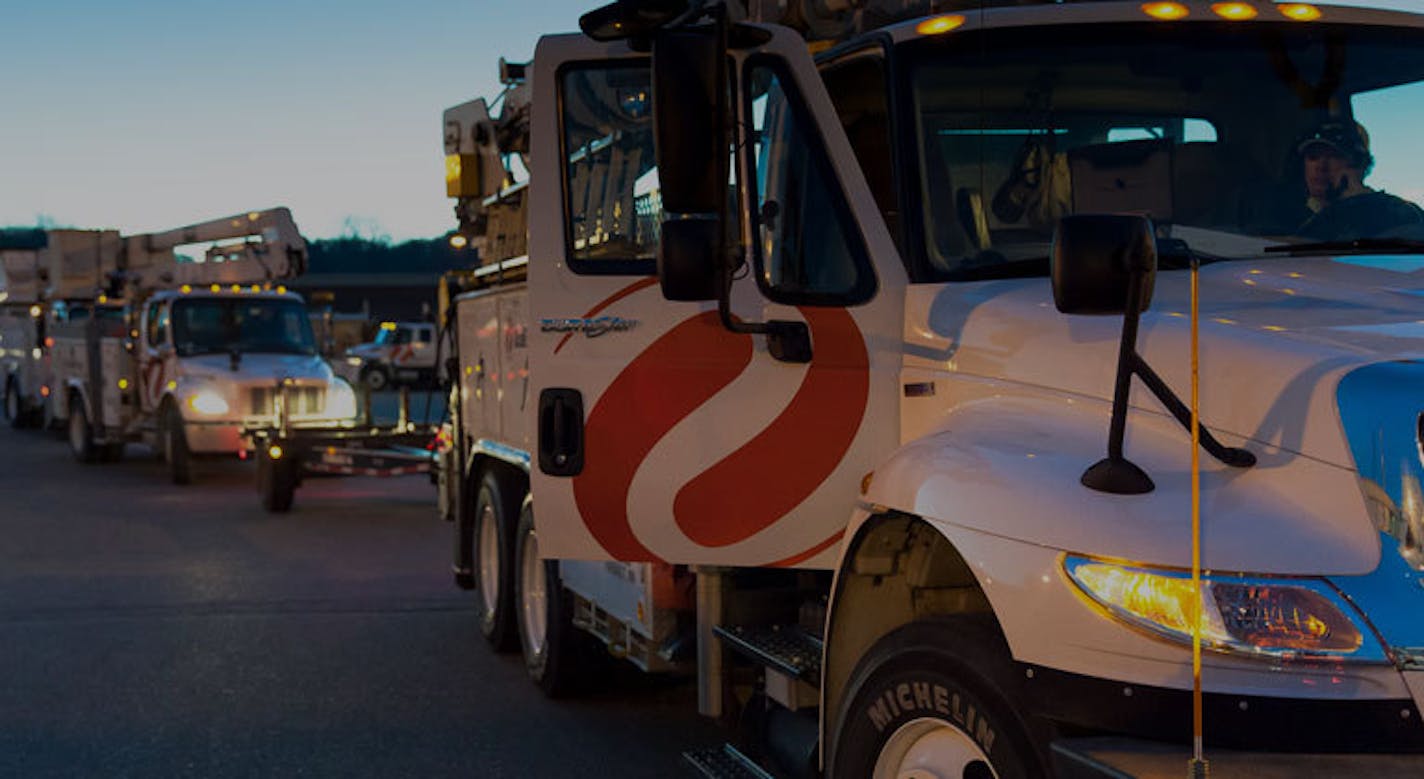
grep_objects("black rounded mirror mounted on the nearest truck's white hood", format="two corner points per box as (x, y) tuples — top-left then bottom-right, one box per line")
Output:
(1049, 214), (1156, 313)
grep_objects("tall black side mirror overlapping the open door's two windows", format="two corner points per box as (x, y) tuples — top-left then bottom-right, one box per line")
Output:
(652, 24), (729, 300)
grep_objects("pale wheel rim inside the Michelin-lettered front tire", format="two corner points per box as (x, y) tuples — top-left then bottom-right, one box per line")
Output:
(873, 718), (998, 779)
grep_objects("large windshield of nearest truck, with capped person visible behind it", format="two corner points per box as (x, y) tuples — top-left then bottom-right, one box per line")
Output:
(906, 23), (1424, 281)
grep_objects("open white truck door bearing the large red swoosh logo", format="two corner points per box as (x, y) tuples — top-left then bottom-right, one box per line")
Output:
(528, 30), (906, 567)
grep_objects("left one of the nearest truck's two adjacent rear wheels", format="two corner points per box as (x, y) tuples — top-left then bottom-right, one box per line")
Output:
(473, 471), (518, 652)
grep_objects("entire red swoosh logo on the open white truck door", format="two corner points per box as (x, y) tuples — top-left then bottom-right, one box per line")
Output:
(572, 307), (870, 567)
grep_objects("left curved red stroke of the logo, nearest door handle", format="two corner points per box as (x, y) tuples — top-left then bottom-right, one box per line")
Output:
(574, 310), (752, 561)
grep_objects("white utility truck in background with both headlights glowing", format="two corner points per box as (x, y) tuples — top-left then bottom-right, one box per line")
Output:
(53, 208), (356, 484)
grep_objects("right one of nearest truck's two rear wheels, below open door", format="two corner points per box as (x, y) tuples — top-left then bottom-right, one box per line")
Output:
(514, 500), (592, 698)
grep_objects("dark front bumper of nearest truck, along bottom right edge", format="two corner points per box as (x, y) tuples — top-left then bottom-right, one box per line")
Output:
(1051, 736), (1424, 779)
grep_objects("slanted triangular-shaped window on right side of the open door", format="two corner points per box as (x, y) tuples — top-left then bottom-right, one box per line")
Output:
(748, 66), (876, 305)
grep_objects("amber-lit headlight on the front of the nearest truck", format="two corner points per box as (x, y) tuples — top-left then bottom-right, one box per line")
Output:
(1064, 555), (1387, 662)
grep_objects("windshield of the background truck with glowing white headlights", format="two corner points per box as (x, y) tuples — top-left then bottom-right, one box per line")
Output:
(172, 298), (316, 355)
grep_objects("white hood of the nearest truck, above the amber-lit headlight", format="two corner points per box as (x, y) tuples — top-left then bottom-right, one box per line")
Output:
(899, 256), (1424, 575)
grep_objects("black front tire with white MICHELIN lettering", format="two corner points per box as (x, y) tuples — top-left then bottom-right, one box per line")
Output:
(829, 619), (1047, 779)
